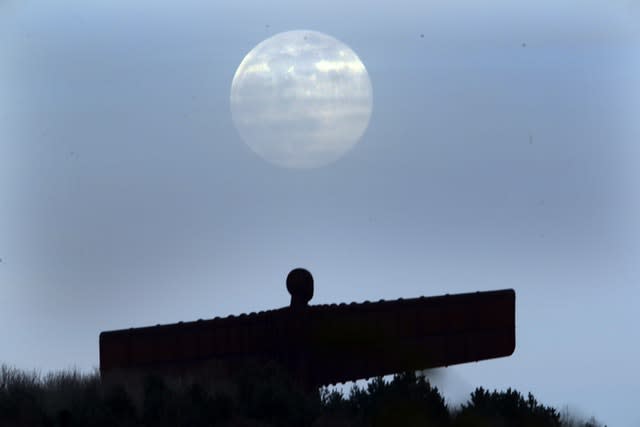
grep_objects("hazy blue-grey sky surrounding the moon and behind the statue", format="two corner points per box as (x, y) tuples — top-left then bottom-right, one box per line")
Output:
(0, 0), (640, 426)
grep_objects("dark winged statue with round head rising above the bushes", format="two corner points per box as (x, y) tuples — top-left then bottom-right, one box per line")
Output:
(100, 268), (515, 388)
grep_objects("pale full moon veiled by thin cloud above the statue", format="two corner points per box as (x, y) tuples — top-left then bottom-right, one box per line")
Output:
(231, 31), (373, 169)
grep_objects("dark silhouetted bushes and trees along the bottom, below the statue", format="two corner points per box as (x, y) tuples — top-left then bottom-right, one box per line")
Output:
(0, 365), (602, 427)
